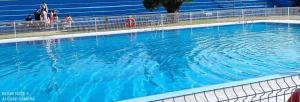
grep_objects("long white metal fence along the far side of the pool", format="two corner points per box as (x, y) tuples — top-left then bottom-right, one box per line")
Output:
(0, 7), (300, 39)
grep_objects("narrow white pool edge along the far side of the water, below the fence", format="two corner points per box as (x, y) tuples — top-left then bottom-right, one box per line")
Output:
(0, 20), (300, 44)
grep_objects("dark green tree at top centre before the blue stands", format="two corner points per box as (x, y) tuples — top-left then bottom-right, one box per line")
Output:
(143, 0), (191, 13)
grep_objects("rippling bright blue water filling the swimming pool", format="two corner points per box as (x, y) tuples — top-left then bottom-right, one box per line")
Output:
(0, 23), (300, 102)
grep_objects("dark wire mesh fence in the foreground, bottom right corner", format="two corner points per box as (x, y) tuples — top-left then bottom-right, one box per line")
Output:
(153, 74), (300, 102)
